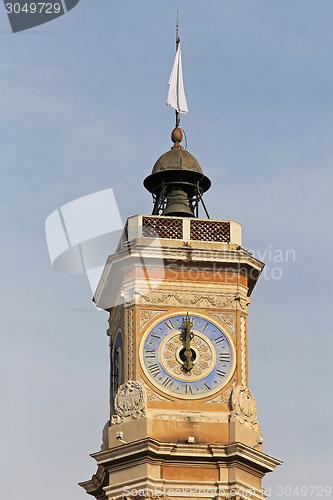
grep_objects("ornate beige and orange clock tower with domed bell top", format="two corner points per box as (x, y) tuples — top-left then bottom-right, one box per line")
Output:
(80, 127), (281, 500)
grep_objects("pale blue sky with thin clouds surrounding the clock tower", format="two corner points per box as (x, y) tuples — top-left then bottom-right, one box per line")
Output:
(0, 0), (333, 500)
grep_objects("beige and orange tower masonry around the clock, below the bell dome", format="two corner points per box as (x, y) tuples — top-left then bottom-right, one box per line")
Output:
(81, 215), (281, 500)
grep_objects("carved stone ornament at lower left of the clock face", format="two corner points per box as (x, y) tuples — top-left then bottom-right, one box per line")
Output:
(114, 380), (147, 418)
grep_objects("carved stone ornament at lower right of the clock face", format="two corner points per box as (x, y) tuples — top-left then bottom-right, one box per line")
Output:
(231, 385), (259, 430)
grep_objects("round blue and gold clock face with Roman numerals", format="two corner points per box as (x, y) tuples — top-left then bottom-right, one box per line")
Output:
(140, 313), (235, 399)
